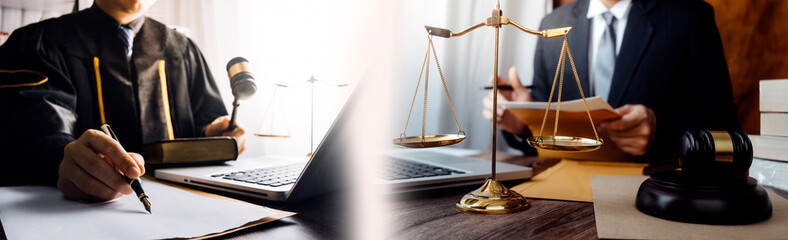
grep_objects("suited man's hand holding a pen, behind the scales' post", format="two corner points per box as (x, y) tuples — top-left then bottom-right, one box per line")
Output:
(482, 67), (533, 135)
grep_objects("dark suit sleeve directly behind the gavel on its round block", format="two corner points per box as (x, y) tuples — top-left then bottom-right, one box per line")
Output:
(644, 1), (740, 159)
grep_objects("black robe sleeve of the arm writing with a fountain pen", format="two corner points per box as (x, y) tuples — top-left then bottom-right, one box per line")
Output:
(0, 23), (76, 186)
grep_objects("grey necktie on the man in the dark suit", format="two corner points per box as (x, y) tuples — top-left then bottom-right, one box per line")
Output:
(594, 11), (616, 101)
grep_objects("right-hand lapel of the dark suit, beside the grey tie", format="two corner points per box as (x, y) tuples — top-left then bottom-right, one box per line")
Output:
(608, 0), (656, 107)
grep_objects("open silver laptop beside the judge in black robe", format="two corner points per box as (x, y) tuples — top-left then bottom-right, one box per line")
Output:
(154, 93), (354, 201)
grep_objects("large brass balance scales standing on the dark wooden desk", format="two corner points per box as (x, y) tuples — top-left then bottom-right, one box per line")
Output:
(393, 1), (603, 214)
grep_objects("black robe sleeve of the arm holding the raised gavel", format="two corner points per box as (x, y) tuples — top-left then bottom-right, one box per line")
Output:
(184, 39), (227, 136)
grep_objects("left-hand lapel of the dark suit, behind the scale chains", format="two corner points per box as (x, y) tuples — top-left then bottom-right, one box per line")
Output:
(566, 0), (590, 98)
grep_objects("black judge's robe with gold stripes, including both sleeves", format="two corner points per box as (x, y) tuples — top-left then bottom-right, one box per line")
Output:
(0, 5), (227, 186)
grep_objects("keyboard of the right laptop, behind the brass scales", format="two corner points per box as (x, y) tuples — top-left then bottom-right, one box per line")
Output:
(383, 159), (465, 180)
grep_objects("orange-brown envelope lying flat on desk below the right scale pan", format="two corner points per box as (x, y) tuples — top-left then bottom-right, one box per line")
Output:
(512, 159), (647, 202)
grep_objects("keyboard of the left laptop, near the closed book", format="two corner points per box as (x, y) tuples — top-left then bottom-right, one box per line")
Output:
(211, 163), (304, 187)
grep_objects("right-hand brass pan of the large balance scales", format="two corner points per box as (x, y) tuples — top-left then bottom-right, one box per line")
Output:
(527, 136), (602, 152)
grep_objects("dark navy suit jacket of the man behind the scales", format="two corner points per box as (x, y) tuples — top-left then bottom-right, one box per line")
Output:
(508, 0), (739, 160)
